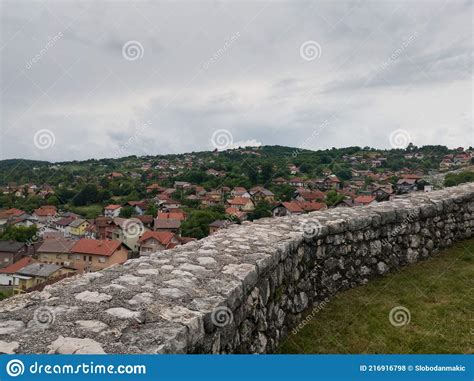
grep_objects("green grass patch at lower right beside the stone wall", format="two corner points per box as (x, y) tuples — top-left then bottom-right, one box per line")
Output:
(279, 239), (474, 354)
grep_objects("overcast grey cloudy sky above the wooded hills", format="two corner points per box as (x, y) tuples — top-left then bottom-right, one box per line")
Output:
(0, 0), (474, 161)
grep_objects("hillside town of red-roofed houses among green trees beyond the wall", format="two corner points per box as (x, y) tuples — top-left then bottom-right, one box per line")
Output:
(0, 144), (474, 298)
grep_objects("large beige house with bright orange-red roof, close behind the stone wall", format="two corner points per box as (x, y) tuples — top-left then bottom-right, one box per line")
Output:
(71, 238), (129, 272)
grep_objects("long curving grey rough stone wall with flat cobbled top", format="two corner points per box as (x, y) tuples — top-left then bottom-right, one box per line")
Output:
(0, 184), (474, 353)
